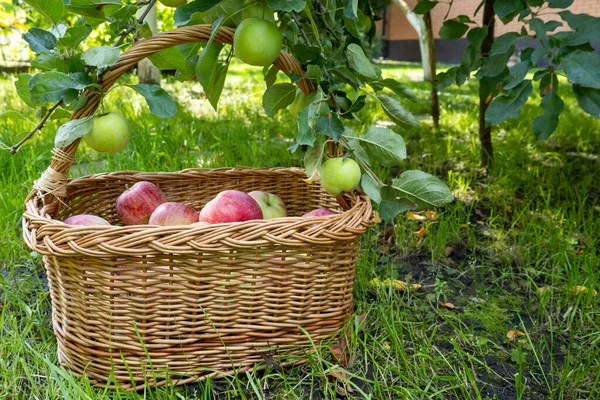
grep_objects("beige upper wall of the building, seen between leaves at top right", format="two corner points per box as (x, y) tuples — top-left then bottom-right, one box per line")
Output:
(379, 0), (600, 41)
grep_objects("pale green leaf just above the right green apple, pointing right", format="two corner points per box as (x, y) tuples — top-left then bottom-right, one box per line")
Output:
(351, 126), (406, 167)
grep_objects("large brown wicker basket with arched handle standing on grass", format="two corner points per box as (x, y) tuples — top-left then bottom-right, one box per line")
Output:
(23, 25), (371, 389)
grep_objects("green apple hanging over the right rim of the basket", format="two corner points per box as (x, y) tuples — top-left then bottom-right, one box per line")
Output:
(319, 157), (360, 196)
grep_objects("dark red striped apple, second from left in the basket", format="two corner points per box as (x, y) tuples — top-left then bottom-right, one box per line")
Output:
(117, 181), (167, 225)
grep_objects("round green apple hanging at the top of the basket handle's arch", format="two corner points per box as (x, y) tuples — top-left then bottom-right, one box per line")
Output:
(233, 18), (283, 67)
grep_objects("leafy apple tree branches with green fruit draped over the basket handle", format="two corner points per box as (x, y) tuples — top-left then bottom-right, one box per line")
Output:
(11, 0), (452, 220)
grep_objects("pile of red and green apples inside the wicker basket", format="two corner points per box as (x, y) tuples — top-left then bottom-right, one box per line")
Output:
(63, 181), (337, 226)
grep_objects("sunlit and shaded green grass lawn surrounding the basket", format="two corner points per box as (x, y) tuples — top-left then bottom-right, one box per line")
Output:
(0, 60), (600, 399)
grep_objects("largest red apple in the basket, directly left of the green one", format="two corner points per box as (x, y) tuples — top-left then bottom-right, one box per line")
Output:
(199, 190), (263, 224)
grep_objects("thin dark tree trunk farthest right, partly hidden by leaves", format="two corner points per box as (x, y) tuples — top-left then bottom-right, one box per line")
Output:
(479, 0), (496, 168)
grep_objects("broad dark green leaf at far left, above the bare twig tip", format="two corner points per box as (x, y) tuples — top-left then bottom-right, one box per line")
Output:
(27, 71), (93, 104)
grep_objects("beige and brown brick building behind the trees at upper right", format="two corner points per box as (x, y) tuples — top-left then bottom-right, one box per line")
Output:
(378, 0), (600, 64)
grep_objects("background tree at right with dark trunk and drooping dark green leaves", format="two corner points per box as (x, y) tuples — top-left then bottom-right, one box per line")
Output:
(421, 0), (600, 167)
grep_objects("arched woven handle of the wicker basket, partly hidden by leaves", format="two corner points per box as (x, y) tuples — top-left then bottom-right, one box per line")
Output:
(34, 25), (315, 202)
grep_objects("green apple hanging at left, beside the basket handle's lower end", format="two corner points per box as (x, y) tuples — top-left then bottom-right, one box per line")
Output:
(83, 112), (131, 153)
